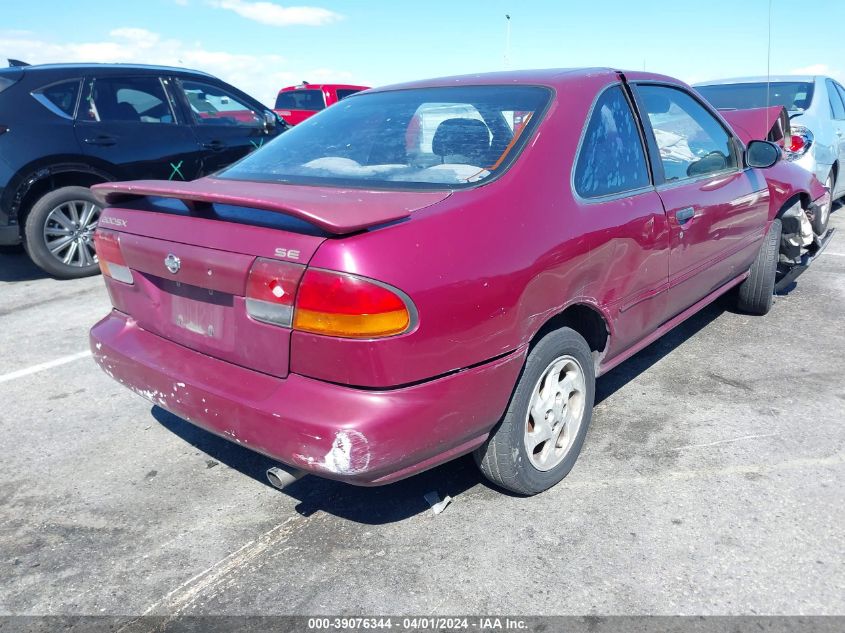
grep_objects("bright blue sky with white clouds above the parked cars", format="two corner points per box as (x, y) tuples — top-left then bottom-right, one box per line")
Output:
(0, 0), (845, 105)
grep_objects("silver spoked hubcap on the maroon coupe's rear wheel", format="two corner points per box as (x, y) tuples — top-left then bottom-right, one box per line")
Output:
(525, 356), (586, 471)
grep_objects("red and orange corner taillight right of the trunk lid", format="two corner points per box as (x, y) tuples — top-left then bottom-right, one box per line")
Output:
(293, 269), (414, 338)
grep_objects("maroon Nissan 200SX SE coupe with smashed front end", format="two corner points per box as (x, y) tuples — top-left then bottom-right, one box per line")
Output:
(91, 69), (830, 494)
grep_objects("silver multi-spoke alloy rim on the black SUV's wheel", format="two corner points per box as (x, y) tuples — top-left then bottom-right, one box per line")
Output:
(44, 200), (102, 268)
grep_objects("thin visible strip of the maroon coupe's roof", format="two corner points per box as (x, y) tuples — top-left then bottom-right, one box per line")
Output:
(370, 68), (681, 92)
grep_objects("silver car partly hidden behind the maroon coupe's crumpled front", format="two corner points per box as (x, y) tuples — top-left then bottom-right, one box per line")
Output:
(695, 75), (845, 235)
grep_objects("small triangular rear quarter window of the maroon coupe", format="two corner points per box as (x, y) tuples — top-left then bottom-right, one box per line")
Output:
(575, 86), (649, 198)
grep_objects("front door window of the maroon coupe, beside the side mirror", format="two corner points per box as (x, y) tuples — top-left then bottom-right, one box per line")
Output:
(637, 85), (737, 182)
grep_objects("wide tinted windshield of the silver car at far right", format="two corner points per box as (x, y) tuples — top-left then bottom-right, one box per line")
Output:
(695, 81), (813, 112)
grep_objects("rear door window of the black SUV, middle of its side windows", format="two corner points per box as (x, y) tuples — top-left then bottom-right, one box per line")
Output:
(78, 77), (175, 123)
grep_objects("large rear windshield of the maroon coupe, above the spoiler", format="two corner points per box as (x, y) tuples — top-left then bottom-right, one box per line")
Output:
(218, 86), (551, 189)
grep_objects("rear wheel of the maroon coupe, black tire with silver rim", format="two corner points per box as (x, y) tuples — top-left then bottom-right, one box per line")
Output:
(474, 327), (596, 495)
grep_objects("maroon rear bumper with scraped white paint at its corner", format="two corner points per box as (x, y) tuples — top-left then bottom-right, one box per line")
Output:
(91, 311), (525, 486)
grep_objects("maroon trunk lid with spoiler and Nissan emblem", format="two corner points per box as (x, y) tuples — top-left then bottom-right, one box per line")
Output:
(93, 179), (449, 378)
